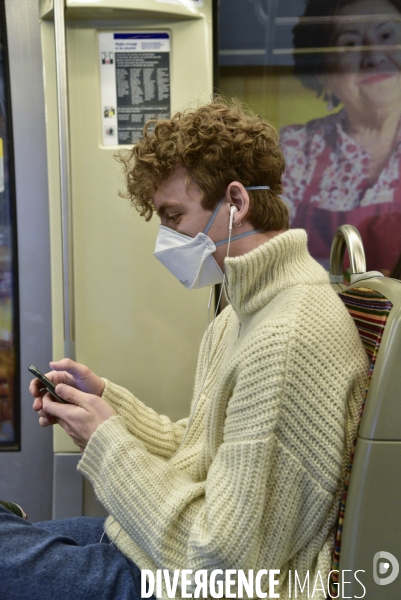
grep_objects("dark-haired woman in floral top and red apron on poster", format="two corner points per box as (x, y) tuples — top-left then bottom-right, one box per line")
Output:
(281, 0), (401, 274)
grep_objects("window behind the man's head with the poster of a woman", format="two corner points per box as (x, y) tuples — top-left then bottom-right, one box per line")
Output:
(218, 0), (401, 277)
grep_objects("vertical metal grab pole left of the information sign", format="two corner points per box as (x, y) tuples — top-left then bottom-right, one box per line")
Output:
(54, 0), (75, 360)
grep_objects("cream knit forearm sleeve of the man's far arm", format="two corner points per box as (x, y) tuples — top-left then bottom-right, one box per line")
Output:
(103, 379), (188, 459)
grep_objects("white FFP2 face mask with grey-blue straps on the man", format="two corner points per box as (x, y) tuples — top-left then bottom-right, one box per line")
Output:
(153, 185), (270, 290)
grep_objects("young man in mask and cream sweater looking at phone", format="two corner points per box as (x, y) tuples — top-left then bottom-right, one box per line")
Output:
(0, 100), (367, 600)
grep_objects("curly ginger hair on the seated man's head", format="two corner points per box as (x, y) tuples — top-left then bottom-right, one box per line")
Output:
(117, 98), (289, 231)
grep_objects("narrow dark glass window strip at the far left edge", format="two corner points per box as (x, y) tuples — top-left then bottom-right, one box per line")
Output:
(0, 2), (20, 450)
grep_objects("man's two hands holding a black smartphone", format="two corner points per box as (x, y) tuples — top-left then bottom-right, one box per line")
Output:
(29, 358), (117, 450)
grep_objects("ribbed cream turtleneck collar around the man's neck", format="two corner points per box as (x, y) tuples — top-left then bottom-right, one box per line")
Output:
(224, 229), (329, 318)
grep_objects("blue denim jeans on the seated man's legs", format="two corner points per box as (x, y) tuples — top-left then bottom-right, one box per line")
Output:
(0, 506), (155, 600)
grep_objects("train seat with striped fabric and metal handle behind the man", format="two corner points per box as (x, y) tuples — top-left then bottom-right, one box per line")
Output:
(330, 225), (401, 600)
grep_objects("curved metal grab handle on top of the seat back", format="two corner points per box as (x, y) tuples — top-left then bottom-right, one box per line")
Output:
(330, 225), (366, 283)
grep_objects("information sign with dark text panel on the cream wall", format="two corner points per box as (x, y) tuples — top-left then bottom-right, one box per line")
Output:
(99, 31), (170, 146)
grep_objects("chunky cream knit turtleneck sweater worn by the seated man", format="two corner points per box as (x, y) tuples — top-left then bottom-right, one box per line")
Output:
(79, 230), (368, 599)
